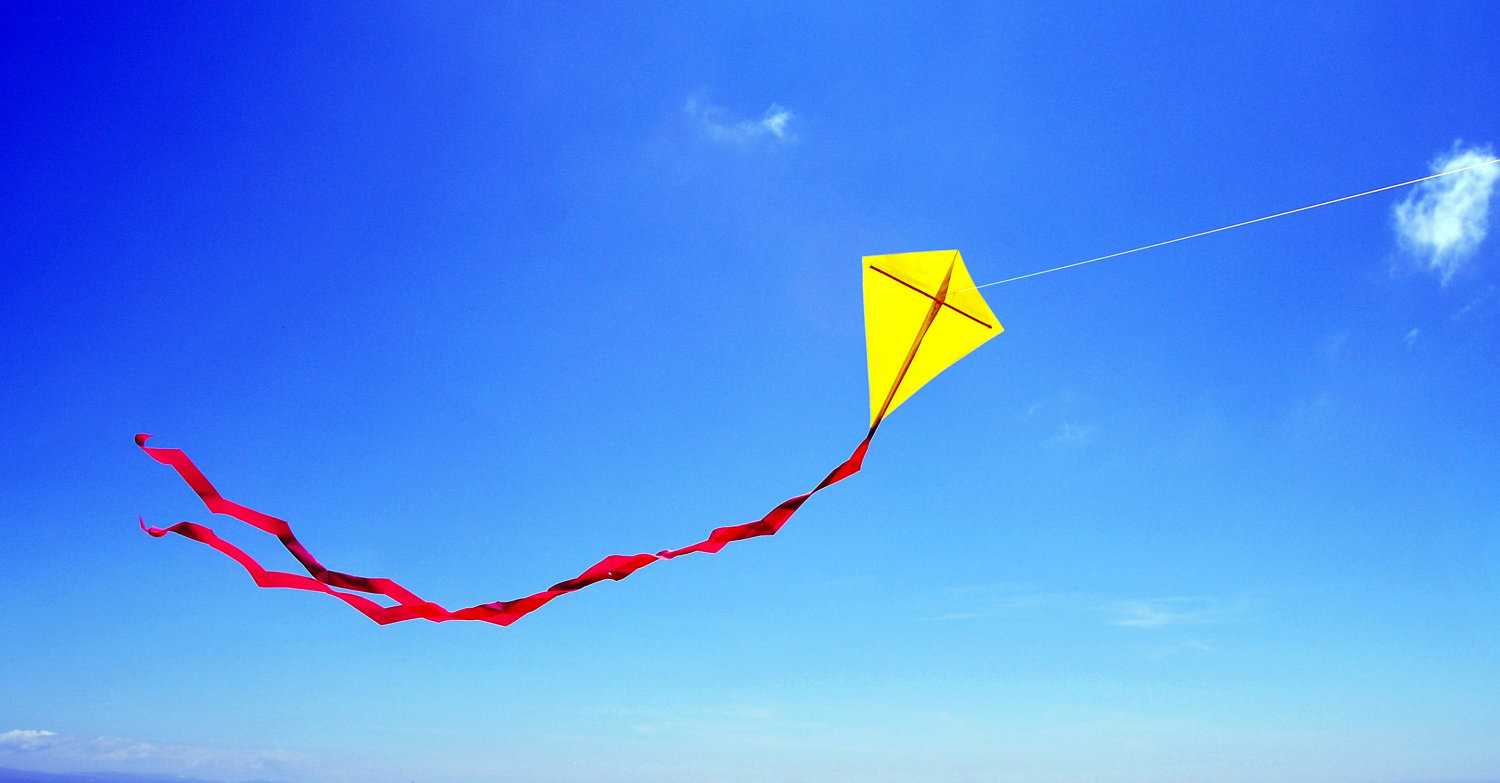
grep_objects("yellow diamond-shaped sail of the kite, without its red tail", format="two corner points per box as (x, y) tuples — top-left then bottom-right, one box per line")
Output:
(864, 251), (1004, 428)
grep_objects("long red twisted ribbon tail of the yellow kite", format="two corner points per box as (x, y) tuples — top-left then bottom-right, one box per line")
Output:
(135, 422), (879, 626)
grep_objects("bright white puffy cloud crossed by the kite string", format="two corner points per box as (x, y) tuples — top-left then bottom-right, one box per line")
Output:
(1392, 141), (1500, 284)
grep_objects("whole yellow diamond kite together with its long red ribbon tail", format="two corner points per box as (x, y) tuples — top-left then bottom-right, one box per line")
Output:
(135, 251), (1002, 626)
